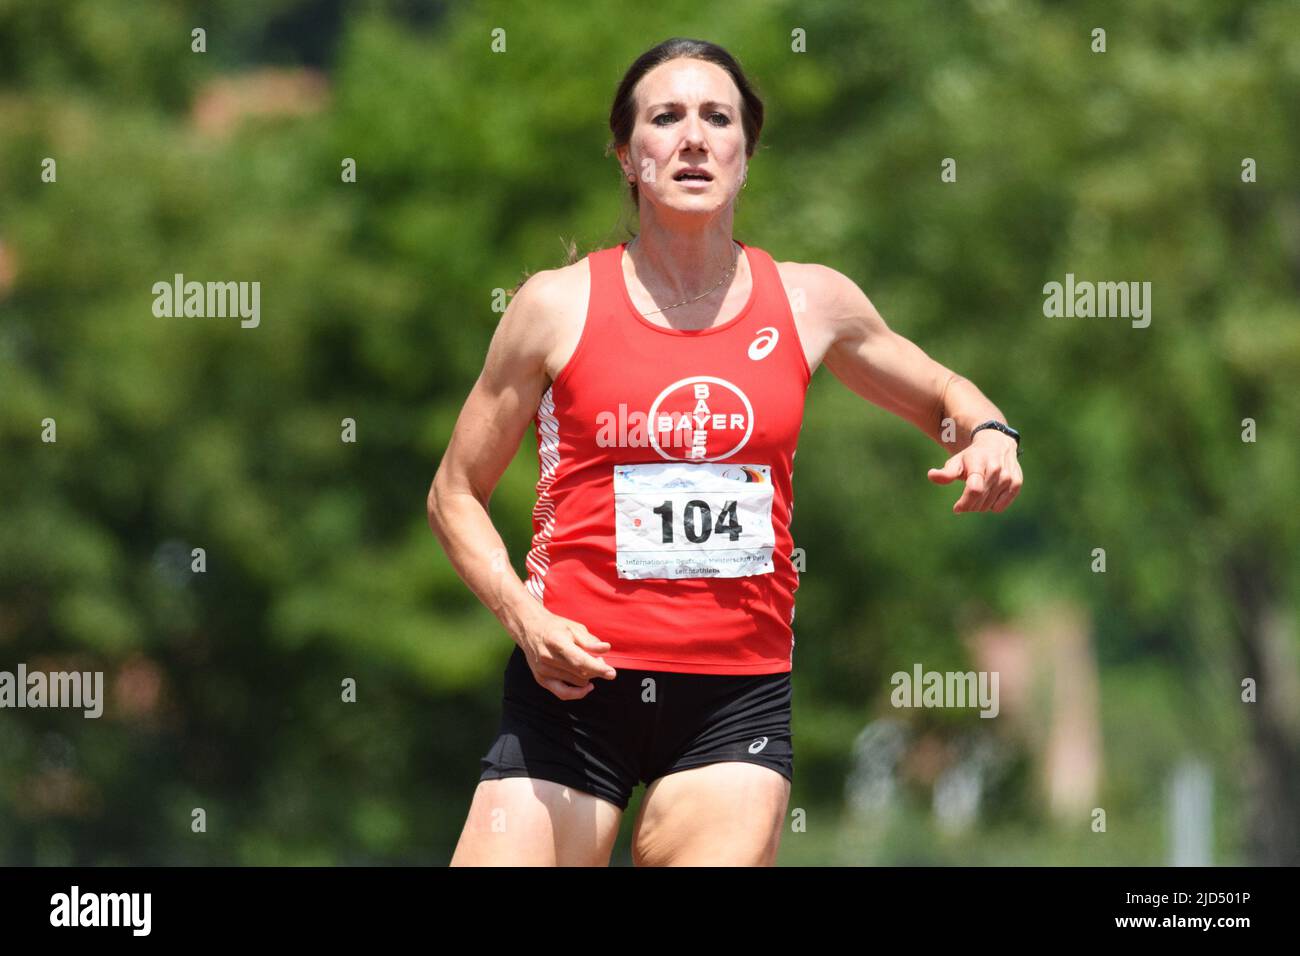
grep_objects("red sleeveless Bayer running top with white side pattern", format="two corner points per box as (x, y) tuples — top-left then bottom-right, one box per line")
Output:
(525, 243), (811, 674)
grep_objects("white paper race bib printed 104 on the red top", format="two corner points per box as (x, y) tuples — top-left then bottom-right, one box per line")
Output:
(614, 462), (776, 578)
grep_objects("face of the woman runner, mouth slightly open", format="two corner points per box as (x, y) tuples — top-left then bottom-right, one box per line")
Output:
(619, 59), (746, 212)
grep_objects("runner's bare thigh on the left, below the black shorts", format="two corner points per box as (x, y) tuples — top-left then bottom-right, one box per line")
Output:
(451, 777), (623, 866)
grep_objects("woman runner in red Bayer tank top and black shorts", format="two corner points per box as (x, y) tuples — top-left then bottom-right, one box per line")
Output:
(428, 38), (1022, 865)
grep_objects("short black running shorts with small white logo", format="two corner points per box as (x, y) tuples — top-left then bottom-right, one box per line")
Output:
(478, 646), (794, 810)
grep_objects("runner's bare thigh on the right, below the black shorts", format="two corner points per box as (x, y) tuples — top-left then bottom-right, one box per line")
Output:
(632, 761), (790, 866)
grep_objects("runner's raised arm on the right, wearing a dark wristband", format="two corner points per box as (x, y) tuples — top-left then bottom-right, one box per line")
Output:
(813, 265), (1024, 514)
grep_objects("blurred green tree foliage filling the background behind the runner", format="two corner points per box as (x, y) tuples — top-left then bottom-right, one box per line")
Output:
(0, 0), (1300, 864)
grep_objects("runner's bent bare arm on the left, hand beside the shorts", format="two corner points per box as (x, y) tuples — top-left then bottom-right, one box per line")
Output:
(428, 271), (615, 700)
